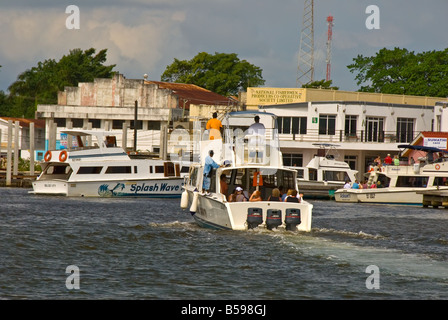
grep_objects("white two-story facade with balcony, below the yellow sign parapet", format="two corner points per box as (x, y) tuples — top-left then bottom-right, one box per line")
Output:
(259, 101), (448, 178)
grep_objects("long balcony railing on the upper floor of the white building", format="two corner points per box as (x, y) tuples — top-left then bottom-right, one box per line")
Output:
(279, 129), (419, 143)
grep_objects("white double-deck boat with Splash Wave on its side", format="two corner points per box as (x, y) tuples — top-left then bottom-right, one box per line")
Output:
(30, 130), (188, 198)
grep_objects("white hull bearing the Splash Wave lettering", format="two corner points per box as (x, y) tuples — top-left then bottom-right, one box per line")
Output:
(31, 178), (184, 198)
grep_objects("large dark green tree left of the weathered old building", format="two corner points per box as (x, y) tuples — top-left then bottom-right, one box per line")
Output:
(8, 48), (115, 118)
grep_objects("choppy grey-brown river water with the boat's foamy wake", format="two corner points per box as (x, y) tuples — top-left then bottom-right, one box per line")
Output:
(0, 188), (448, 301)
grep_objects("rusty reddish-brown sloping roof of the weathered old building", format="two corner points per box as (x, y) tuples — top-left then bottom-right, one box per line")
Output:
(145, 80), (237, 109)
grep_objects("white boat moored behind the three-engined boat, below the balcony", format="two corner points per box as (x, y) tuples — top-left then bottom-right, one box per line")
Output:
(290, 143), (358, 198)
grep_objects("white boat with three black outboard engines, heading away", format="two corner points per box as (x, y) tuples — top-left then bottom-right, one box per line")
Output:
(181, 111), (313, 231)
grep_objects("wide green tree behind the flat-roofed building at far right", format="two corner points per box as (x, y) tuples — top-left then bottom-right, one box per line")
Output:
(347, 48), (448, 97)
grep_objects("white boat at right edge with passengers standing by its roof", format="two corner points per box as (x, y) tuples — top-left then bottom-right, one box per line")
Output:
(335, 145), (448, 205)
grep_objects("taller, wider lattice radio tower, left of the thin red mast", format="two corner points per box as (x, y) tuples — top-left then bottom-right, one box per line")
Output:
(297, 0), (314, 87)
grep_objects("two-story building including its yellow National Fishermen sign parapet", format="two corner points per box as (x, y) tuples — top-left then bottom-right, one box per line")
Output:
(244, 88), (448, 178)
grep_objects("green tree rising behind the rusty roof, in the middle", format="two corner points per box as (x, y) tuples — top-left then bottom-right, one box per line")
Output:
(161, 52), (265, 96)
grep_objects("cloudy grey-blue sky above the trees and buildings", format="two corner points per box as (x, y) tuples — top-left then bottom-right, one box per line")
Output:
(0, 0), (448, 92)
